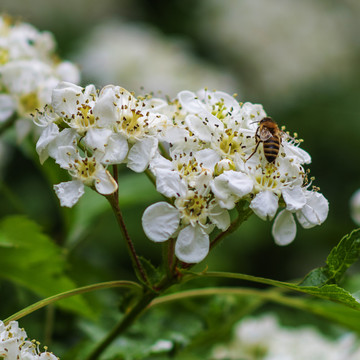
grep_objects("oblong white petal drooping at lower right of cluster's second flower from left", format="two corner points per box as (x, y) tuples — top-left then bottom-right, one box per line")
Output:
(127, 137), (158, 172)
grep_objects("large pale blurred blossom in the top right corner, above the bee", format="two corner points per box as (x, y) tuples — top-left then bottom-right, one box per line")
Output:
(198, 0), (359, 102)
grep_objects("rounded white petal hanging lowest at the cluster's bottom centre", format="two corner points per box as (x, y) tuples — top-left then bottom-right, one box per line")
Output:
(175, 225), (210, 264)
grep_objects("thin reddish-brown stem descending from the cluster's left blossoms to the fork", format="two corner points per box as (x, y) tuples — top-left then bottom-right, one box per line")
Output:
(106, 191), (149, 285)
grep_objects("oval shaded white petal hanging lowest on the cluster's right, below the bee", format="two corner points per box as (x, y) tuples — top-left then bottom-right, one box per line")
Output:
(272, 209), (296, 245)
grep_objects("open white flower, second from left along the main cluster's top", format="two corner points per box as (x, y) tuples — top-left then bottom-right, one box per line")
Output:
(86, 85), (168, 172)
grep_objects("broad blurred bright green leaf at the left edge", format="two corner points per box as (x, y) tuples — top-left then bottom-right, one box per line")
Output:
(0, 216), (93, 317)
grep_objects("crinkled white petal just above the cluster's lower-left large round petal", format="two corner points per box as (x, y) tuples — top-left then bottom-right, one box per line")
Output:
(156, 169), (187, 198)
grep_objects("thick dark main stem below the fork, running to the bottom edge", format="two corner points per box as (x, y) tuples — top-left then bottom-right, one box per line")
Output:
(86, 292), (158, 360)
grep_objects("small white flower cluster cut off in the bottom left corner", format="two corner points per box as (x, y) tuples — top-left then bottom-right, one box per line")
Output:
(0, 321), (58, 360)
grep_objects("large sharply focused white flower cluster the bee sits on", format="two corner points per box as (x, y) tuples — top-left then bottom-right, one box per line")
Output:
(35, 83), (328, 263)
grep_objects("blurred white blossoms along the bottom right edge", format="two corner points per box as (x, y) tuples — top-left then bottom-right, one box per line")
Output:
(211, 314), (360, 360)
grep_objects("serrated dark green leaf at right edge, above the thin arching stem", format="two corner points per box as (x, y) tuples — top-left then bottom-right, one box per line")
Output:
(301, 229), (360, 286)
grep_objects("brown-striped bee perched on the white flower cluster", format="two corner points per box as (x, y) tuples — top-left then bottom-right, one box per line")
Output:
(246, 117), (283, 163)
